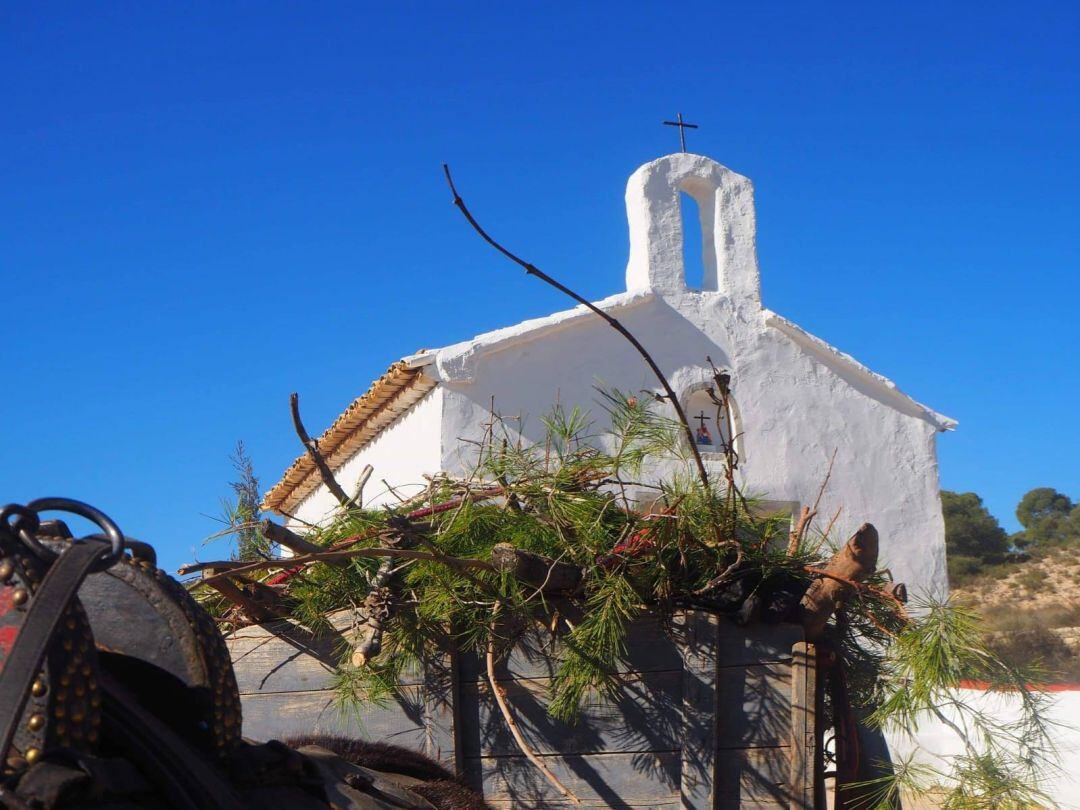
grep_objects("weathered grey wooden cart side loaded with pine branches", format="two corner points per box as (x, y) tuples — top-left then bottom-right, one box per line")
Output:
(227, 611), (824, 810)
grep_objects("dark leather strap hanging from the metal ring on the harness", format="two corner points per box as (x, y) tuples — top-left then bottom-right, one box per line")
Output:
(0, 539), (109, 756)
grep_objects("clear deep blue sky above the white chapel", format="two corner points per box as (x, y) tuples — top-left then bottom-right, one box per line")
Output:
(0, 2), (1080, 567)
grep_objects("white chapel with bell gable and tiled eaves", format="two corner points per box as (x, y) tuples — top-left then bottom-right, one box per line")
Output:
(264, 152), (956, 595)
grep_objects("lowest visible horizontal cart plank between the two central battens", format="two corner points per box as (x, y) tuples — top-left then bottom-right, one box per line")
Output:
(465, 751), (679, 808)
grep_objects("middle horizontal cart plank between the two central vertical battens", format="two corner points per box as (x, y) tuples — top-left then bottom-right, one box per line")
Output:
(460, 672), (683, 757)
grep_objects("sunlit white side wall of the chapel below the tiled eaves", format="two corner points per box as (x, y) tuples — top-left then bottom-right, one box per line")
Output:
(295, 388), (443, 527)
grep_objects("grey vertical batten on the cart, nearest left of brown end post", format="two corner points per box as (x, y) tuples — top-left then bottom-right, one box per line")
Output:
(675, 611), (719, 810)
